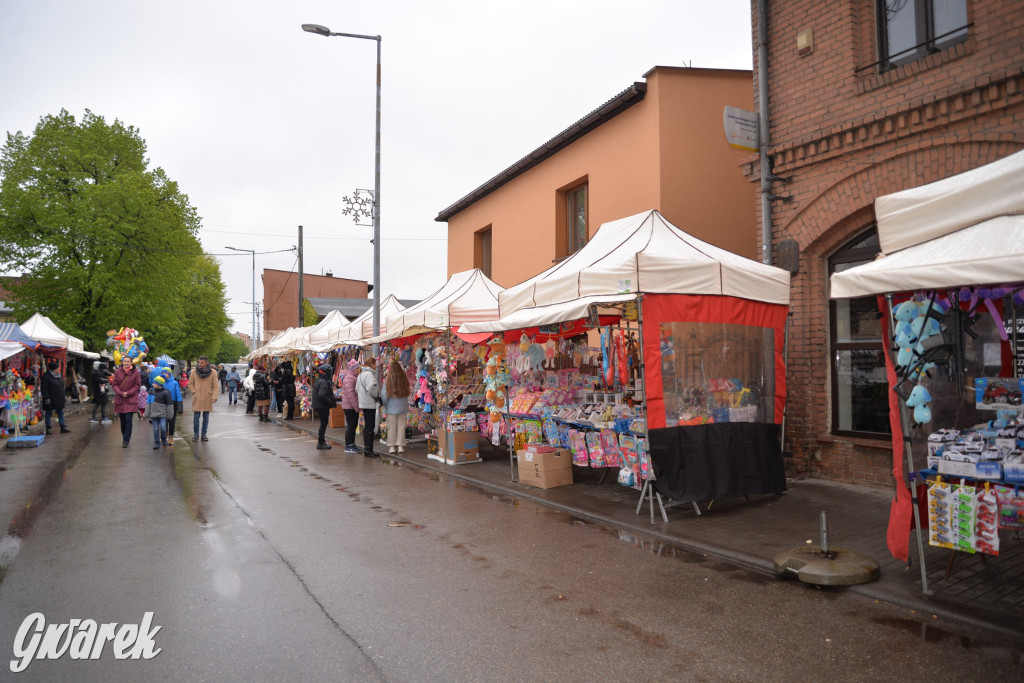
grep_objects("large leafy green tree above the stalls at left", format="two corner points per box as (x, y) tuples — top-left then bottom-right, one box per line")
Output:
(0, 110), (227, 357)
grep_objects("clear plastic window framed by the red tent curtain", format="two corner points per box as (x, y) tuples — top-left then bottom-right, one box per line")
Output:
(660, 323), (775, 427)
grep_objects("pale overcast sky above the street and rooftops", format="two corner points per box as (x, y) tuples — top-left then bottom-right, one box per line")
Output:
(0, 0), (753, 333)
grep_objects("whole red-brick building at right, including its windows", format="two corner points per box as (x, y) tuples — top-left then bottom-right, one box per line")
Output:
(744, 0), (1024, 486)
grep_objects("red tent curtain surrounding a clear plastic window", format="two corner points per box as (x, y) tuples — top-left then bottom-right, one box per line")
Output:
(642, 294), (790, 429)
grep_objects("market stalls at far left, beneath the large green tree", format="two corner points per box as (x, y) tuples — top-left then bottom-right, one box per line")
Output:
(0, 313), (99, 436)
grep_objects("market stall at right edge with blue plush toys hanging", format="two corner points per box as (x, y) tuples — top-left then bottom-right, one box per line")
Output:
(830, 148), (1024, 593)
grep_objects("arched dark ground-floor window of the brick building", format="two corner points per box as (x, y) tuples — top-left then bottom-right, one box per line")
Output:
(828, 226), (891, 438)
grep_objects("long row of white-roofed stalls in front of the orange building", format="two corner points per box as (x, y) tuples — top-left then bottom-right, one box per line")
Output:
(245, 211), (790, 517)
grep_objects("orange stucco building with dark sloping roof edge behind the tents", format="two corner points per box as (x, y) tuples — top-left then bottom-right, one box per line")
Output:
(436, 67), (757, 287)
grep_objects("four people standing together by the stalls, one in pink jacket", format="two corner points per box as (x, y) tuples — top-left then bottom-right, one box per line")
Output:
(312, 357), (411, 458)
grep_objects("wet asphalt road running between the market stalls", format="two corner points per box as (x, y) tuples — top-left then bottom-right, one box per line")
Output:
(0, 401), (1024, 681)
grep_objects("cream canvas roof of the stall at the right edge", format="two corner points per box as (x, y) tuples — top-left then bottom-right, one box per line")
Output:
(829, 152), (1024, 299)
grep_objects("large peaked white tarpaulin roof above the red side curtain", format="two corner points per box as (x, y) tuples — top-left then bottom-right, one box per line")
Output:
(460, 211), (790, 333)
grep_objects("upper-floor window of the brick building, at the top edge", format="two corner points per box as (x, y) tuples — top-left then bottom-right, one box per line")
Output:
(878, 0), (968, 69)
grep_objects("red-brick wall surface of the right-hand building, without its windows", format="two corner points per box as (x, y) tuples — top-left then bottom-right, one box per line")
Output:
(744, 0), (1024, 486)
